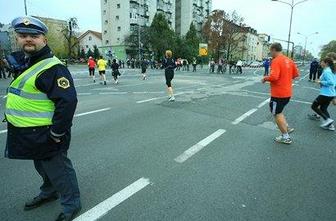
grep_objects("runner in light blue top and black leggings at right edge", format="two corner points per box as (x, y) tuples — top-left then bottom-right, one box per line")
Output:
(308, 57), (336, 131)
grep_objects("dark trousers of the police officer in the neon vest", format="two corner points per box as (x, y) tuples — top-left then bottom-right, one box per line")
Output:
(34, 151), (81, 214)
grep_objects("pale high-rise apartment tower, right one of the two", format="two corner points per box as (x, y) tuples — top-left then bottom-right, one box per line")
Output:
(175, 0), (212, 36)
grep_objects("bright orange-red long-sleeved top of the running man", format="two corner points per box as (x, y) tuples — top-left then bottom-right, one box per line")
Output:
(264, 55), (299, 98)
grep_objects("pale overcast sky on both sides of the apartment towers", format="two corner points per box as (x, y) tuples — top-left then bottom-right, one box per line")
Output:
(0, 0), (336, 55)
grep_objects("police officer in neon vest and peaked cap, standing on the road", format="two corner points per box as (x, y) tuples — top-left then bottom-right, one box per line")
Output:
(5, 17), (81, 221)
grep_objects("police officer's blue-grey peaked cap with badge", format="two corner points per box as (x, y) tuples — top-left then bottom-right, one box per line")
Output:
(12, 16), (48, 35)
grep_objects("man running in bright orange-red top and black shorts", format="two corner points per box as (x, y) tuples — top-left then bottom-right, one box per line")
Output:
(262, 43), (299, 144)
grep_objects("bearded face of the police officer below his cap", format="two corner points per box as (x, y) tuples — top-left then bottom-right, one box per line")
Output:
(16, 33), (47, 54)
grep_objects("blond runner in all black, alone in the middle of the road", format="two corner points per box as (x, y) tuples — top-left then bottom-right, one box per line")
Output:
(162, 50), (176, 101)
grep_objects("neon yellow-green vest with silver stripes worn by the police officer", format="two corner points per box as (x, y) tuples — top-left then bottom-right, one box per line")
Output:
(5, 57), (62, 127)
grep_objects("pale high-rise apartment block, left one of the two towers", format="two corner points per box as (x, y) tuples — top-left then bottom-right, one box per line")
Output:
(101, 0), (175, 60)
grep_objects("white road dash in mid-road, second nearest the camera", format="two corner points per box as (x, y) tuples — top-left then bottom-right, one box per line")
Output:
(175, 129), (226, 163)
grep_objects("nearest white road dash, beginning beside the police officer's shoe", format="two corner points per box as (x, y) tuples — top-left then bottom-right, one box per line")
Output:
(74, 178), (150, 221)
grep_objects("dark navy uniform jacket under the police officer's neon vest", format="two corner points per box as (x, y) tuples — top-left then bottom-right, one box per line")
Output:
(5, 46), (77, 159)
